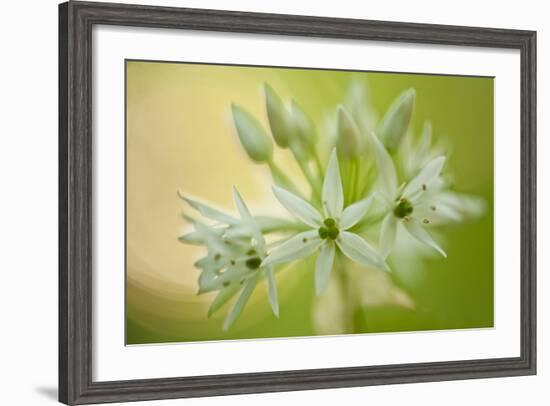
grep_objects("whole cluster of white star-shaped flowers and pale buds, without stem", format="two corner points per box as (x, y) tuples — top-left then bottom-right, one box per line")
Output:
(179, 83), (483, 329)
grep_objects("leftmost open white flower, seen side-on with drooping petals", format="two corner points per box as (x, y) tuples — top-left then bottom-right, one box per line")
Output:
(182, 188), (279, 330)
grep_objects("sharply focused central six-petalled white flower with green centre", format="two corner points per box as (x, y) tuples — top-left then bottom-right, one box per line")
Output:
(262, 150), (389, 294)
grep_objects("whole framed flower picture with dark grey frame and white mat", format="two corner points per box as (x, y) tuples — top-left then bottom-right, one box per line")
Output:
(59, 2), (536, 404)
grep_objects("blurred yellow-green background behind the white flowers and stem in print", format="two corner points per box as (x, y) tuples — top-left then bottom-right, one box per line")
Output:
(126, 61), (494, 344)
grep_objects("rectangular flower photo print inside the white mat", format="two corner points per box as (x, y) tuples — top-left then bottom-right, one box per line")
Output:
(125, 60), (494, 345)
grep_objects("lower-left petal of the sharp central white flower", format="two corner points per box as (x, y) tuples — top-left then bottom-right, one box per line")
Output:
(262, 230), (324, 266)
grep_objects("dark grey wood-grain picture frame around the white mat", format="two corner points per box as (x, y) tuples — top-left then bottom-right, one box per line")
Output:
(59, 2), (536, 404)
